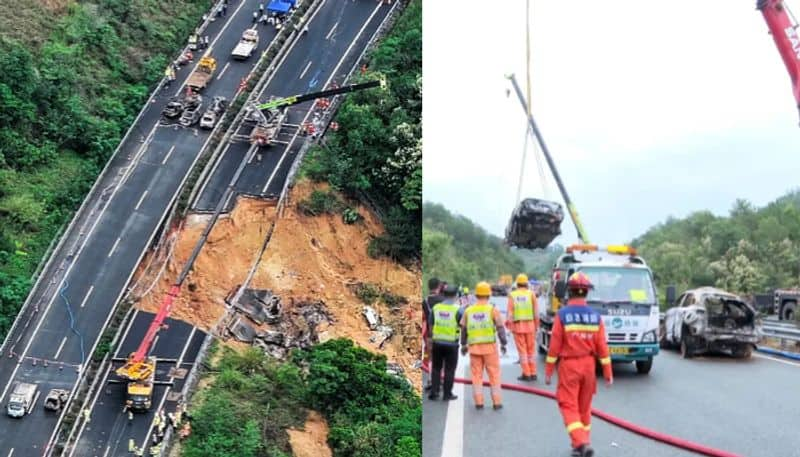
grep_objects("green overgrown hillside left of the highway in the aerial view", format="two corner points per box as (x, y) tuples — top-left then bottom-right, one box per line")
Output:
(0, 0), (211, 337)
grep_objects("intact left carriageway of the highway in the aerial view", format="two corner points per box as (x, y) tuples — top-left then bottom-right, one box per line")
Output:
(0, 0), (275, 457)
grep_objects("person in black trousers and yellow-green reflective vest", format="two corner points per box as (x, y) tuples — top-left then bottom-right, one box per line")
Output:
(427, 286), (463, 400)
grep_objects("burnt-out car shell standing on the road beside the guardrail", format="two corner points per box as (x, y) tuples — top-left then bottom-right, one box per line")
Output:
(660, 287), (761, 358)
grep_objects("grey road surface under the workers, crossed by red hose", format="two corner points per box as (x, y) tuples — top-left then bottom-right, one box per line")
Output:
(423, 300), (800, 457)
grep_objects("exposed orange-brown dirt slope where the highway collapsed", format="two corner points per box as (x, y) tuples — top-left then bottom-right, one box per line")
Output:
(136, 181), (422, 386)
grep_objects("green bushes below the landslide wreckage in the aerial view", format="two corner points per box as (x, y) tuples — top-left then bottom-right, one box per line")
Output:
(183, 339), (422, 457)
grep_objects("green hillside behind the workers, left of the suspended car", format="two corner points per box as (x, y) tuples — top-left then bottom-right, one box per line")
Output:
(422, 202), (525, 289)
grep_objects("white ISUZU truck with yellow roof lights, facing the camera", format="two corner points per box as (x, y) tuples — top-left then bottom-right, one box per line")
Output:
(537, 245), (659, 374)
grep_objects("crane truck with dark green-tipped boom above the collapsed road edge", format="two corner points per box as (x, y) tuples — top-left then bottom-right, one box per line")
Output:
(238, 79), (386, 146)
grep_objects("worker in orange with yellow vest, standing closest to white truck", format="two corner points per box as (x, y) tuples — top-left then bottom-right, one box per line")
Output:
(506, 274), (539, 381)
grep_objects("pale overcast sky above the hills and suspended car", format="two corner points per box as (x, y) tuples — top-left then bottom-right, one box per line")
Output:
(423, 0), (800, 244)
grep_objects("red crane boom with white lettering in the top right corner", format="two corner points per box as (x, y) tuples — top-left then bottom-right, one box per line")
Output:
(756, 0), (800, 119)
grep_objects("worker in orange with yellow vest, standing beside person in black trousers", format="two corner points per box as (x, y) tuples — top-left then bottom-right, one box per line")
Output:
(461, 282), (508, 410)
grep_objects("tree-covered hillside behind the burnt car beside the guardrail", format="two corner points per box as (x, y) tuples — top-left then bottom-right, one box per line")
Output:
(633, 191), (800, 300)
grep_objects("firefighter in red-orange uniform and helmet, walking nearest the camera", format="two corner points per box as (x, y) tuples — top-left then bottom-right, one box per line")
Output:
(545, 272), (614, 457)
